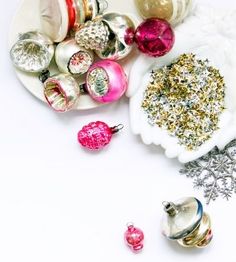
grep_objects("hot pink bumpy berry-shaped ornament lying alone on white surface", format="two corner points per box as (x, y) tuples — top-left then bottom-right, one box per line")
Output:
(78, 121), (124, 150)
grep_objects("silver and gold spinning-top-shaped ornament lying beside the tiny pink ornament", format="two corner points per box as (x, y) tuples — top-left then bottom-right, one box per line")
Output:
(162, 197), (213, 248)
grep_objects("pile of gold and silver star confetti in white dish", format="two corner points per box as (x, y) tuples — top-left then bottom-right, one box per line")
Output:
(142, 54), (225, 150)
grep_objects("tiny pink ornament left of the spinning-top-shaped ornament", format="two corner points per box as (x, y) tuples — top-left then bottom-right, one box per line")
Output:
(125, 224), (144, 252)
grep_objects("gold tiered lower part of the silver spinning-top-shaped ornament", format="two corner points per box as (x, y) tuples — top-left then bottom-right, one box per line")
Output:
(178, 213), (212, 247)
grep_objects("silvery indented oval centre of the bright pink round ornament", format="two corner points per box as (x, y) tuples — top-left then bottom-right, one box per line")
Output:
(88, 67), (109, 97)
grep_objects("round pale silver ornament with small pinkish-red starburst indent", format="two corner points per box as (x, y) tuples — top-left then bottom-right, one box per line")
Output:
(55, 39), (94, 76)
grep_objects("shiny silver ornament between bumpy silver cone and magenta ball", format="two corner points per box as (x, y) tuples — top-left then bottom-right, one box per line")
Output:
(96, 13), (135, 60)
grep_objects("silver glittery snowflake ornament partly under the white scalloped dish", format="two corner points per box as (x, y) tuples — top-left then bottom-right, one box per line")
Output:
(180, 140), (236, 204)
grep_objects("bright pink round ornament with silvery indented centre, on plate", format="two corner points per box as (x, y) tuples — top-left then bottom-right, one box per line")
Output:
(86, 60), (128, 103)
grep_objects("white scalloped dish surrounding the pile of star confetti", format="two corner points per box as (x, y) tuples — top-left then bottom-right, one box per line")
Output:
(127, 6), (236, 163)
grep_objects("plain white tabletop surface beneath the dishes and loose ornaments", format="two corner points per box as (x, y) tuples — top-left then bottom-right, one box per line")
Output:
(0, 0), (236, 262)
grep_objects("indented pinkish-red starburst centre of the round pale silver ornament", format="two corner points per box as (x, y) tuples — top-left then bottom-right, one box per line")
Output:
(68, 51), (93, 74)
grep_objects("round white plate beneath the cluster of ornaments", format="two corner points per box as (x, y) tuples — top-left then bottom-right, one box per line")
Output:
(9, 0), (139, 110)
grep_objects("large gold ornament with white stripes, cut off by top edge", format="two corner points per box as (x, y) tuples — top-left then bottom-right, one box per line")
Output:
(135, 0), (193, 25)
